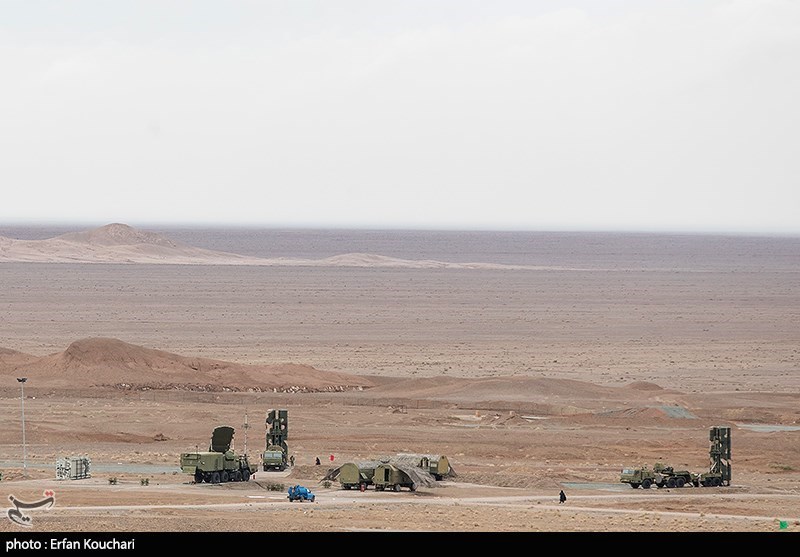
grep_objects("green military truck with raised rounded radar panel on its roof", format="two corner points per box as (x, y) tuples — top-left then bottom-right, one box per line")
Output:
(181, 425), (258, 484)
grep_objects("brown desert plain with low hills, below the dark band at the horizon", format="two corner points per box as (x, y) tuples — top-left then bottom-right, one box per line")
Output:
(0, 225), (800, 534)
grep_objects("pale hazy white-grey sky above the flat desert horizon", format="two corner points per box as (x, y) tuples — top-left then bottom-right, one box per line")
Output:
(0, 0), (800, 234)
